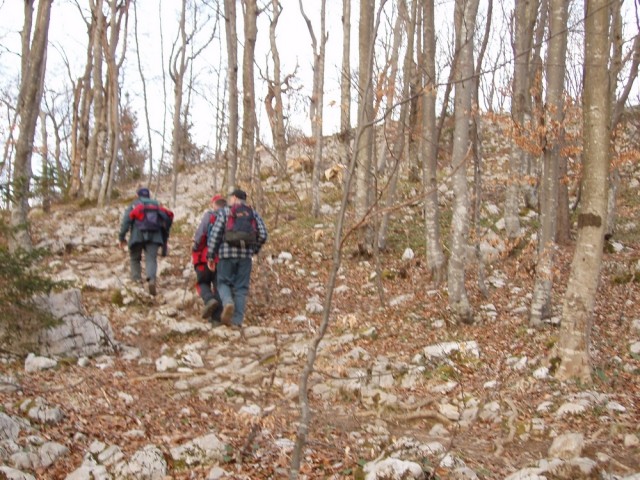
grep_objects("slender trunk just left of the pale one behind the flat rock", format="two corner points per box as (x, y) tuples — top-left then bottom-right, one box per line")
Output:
(420, 0), (445, 284)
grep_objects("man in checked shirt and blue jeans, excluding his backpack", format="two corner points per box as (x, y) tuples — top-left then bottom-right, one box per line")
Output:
(207, 189), (267, 327)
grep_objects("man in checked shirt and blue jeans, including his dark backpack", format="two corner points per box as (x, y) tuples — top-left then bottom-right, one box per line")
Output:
(207, 189), (267, 327)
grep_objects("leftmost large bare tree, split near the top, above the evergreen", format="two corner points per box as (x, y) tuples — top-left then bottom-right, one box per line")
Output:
(9, 0), (52, 252)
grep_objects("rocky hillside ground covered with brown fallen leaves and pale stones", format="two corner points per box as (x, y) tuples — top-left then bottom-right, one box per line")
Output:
(0, 119), (640, 480)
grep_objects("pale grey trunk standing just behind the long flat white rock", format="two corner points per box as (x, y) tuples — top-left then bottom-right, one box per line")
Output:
(448, 0), (479, 323)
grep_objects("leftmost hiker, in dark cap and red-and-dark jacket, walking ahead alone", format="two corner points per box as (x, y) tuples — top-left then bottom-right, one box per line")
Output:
(119, 187), (173, 295)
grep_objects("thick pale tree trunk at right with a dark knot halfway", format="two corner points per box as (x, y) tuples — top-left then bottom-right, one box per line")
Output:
(555, 0), (611, 383)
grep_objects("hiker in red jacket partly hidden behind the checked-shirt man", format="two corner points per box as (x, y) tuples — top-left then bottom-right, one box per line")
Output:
(191, 195), (227, 325)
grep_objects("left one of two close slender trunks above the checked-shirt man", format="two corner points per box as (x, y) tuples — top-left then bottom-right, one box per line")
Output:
(224, 0), (238, 189)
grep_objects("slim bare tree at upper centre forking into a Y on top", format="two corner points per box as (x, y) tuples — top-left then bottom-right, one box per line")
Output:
(299, 0), (329, 217)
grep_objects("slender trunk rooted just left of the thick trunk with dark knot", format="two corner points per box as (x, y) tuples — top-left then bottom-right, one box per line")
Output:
(529, 0), (569, 327)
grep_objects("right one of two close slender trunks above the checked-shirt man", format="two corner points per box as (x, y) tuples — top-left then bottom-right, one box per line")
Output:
(240, 0), (259, 188)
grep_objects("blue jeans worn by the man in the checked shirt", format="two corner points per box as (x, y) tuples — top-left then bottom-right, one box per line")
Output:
(216, 258), (252, 325)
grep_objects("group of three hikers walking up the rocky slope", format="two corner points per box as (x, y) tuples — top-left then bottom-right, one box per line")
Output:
(120, 188), (267, 328)
